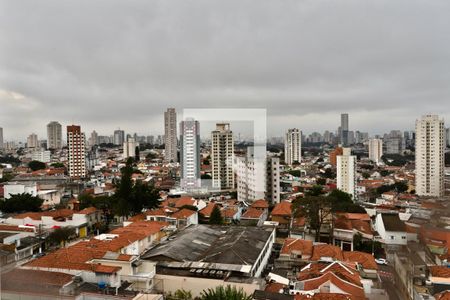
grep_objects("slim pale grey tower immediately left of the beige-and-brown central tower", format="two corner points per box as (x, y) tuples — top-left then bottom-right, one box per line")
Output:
(180, 119), (201, 190)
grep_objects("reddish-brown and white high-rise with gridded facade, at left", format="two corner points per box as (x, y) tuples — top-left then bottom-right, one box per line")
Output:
(67, 125), (86, 178)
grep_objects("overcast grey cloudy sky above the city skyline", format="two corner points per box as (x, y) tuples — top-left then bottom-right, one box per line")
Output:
(0, 0), (450, 140)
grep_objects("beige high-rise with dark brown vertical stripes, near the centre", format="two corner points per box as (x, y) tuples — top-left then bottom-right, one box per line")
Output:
(211, 123), (234, 189)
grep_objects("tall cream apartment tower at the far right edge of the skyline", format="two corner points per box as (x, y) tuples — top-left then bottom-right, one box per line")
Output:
(416, 115), (445, 197)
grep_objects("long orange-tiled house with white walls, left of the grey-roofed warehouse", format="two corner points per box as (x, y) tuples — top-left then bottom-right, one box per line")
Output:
(22, 221), (167, 291)
